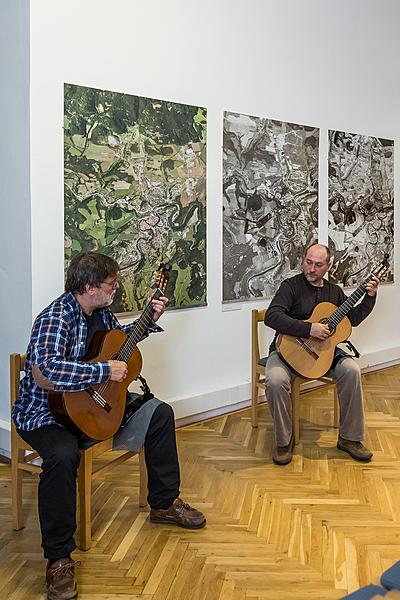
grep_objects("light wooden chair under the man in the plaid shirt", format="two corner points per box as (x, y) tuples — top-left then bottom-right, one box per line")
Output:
(10, 354), (147, 550)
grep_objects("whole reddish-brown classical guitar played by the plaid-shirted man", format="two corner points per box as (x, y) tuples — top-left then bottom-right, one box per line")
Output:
(48, 265), (171, 441)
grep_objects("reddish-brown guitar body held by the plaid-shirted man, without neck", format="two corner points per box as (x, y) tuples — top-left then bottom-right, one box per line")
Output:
(49, 329), (142, 441)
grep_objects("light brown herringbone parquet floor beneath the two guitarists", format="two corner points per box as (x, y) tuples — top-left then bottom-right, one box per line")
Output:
(0, 366), (400, 600)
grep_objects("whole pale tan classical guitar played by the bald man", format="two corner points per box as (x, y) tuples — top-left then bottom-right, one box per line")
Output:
(276, 255), (389, 379)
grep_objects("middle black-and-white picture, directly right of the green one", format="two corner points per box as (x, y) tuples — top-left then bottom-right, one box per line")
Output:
(223, 112), (319, 302)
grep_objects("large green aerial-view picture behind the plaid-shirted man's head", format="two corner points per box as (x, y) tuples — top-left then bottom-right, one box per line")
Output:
(64, 84), (207, 312)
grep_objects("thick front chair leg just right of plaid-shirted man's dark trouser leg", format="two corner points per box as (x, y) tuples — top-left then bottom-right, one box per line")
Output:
(78, 448), (93, 551)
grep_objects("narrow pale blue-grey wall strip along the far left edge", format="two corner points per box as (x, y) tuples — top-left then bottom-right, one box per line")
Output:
(0, 0), (32, 452)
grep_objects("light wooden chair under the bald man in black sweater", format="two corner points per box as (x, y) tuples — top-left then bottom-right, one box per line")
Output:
(251, 308), (339, 444)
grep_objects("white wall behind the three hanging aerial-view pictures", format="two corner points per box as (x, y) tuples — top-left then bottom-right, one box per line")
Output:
(3, 0), (400, 450)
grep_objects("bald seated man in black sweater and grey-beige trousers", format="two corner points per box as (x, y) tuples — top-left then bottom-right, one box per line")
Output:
(265, 244), (379, 465)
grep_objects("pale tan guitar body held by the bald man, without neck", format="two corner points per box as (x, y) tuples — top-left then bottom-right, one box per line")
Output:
(276, 302), (351, 379)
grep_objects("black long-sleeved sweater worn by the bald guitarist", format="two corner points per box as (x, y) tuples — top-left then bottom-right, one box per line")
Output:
(265, 273), (376, 352)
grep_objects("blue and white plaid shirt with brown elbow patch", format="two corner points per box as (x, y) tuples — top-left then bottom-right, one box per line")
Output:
(12, 292), (162, 431)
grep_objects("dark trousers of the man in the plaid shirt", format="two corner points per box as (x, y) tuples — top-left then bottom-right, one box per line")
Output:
(18, 403), (180, 560)
